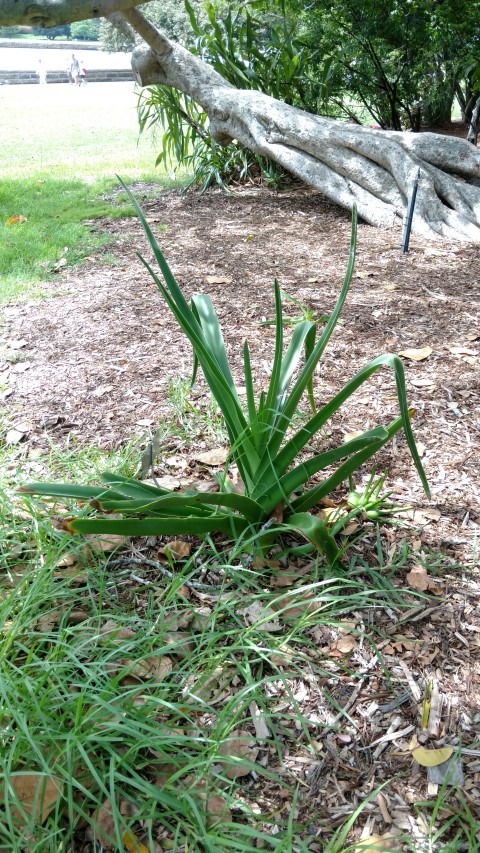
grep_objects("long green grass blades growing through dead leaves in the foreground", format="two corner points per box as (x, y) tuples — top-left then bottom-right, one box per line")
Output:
(0, 396), (477, 853)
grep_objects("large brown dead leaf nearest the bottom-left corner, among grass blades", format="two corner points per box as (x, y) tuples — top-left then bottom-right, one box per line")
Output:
(5, 773), (63, 824)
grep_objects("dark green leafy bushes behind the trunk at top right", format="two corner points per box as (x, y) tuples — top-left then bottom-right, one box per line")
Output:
(294, 0), (480, 130)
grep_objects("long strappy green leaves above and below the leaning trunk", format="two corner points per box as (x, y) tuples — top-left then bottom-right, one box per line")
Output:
(138, 0), (309, 190)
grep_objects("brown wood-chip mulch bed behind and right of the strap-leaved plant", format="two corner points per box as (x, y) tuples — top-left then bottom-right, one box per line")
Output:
(0, 125), (480, 849)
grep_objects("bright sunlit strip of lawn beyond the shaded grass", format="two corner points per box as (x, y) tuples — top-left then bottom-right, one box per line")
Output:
(0, 83), (159, 181)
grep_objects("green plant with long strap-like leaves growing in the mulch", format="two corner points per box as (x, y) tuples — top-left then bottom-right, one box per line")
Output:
(21, 190), (429, 566)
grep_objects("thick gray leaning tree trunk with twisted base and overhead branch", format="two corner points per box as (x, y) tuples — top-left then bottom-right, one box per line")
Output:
(0, 0), (480, 242)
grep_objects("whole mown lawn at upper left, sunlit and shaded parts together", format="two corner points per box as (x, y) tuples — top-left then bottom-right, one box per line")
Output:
(0, 83), (188, 303)
